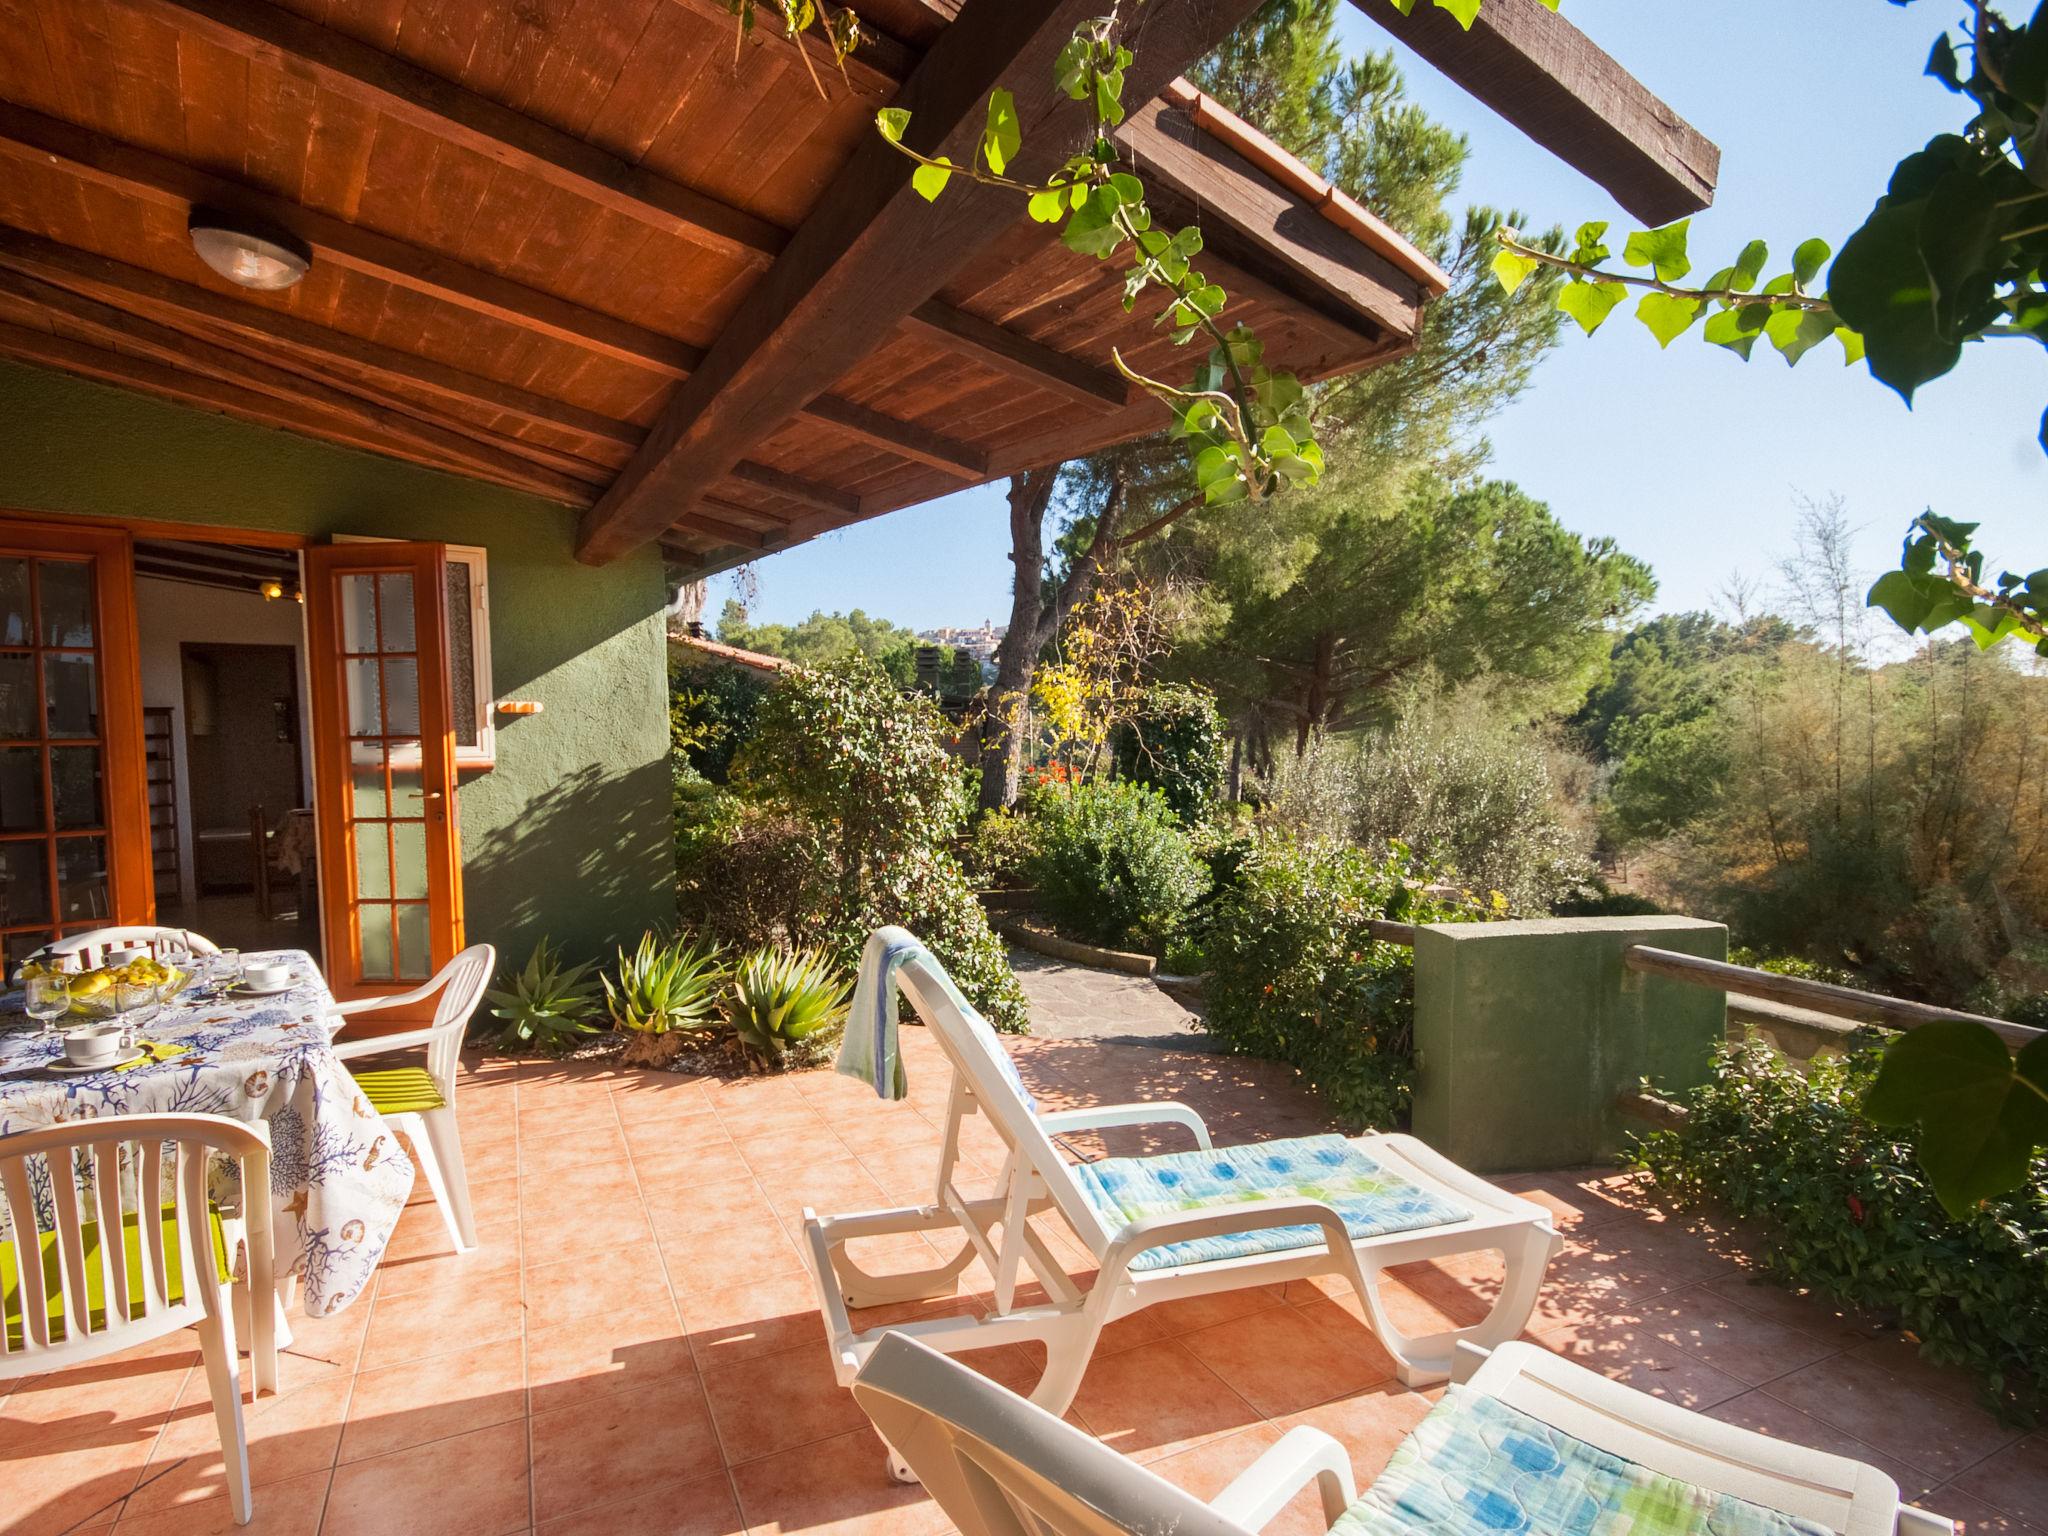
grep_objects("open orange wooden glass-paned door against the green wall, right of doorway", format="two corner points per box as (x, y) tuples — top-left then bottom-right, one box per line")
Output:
(305, 543), (463, 995)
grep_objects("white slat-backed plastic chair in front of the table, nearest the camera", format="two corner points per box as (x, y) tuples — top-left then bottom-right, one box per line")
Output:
(0, 1114), (276, 1526)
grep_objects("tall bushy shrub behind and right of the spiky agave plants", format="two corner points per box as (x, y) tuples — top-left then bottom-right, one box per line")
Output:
(737, 655), (1028, 1030)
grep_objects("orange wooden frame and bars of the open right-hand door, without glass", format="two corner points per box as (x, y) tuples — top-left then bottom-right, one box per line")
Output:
(303, 541), (463, 1018)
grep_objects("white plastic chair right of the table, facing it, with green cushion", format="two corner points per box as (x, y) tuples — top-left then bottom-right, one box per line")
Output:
(334, 944), (498, 1253)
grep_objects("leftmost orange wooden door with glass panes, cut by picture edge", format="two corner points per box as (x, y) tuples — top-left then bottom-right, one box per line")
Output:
(0, 518), (156, 971)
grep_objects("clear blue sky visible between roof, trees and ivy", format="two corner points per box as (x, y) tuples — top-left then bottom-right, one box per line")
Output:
(711, 0), (2048, 629)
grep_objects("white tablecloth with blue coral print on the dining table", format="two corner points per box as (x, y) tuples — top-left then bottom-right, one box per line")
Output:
(0, 950), (412, 1317)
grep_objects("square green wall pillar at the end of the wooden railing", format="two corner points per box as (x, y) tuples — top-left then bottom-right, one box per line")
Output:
(1415, 918), (1729, 1174)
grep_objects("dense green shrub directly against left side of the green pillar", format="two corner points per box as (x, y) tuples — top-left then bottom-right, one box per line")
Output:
(1204, 827), (1458, 1130)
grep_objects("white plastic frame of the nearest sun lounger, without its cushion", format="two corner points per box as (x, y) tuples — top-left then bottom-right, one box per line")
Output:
(854, 1333), (1954, 1536)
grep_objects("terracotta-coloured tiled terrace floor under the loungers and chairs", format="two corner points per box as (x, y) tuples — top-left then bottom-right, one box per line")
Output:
(0, 1030), (2048, 1536)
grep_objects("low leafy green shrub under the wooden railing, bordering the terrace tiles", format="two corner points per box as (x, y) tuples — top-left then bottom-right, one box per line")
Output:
(1640, 1044), (2048, 1419)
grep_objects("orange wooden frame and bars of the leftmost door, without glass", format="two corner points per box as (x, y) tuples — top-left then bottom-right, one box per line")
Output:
(0, 514), (156, 962)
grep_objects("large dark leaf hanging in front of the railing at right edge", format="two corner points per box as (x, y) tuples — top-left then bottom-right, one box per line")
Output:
(1864, 1020), (2048, 1221)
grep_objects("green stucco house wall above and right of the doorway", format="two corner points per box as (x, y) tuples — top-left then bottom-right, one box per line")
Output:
(0, 362), (676, 963)
